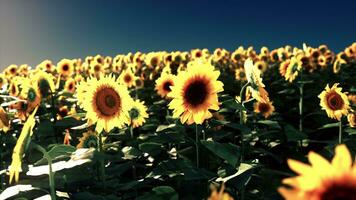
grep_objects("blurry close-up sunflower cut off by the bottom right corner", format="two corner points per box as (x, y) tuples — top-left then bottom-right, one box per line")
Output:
(278, 144), (356, 200)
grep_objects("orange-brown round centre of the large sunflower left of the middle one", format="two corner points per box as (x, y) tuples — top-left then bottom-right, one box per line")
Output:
(95, 87), (121, 116)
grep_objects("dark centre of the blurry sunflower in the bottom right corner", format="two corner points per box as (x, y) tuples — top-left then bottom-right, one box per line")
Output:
(320, 183), (356, 200)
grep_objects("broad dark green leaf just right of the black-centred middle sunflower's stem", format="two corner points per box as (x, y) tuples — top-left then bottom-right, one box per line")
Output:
(201, 140), (241, 168)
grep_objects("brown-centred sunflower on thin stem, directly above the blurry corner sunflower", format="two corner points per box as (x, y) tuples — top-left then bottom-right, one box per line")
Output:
(318, 83), (350, 121)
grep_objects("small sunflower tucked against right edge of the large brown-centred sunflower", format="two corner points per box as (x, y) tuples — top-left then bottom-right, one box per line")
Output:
(128, 100), (148, 128)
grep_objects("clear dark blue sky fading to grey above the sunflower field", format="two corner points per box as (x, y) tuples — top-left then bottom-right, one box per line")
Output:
(0, 0), (356, 69)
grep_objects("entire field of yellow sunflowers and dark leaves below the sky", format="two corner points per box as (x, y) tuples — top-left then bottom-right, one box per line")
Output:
(0, 43), (356, 200)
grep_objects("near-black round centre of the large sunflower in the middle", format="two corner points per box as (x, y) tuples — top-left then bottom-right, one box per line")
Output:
(184, 80), (208, 106)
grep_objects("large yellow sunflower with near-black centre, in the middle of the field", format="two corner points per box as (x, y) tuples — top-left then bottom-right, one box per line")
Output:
(168, 60), (224, 124)
